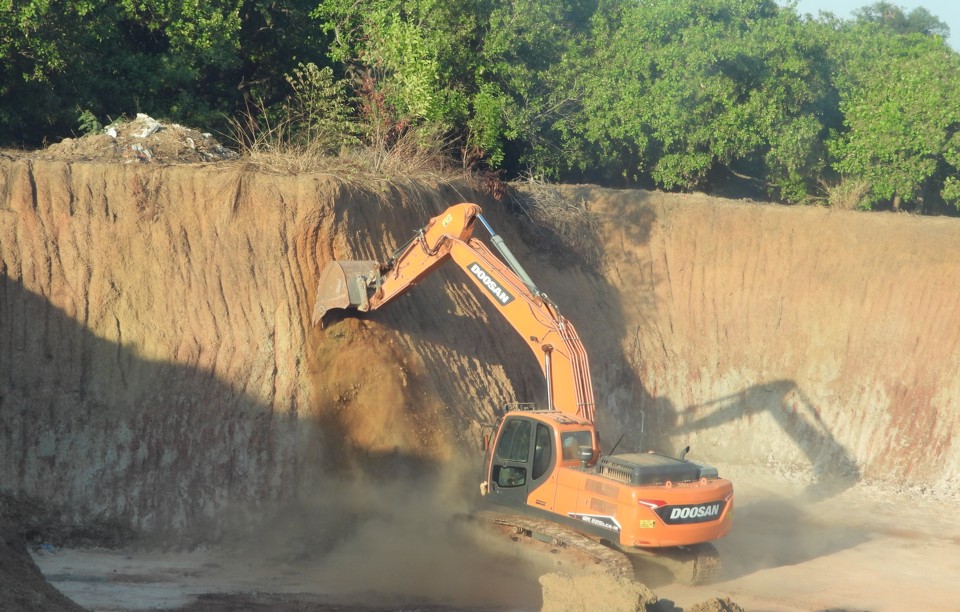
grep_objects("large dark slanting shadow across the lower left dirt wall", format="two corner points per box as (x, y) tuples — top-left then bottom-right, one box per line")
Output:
(0, 274), (448, 547)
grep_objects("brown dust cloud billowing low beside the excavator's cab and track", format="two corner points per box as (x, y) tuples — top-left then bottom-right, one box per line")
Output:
(217, 461), (551, 609)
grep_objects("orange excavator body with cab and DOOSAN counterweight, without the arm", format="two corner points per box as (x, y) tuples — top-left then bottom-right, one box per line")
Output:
(480, 410), (733, 584)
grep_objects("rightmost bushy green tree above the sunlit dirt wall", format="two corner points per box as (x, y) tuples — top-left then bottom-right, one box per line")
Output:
(829, 23), (960, 209)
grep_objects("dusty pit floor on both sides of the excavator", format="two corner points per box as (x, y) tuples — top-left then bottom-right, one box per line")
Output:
(34, 474), (960, 612)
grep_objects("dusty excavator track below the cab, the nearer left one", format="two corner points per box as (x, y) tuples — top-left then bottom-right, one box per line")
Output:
(464, 510), (634, 579)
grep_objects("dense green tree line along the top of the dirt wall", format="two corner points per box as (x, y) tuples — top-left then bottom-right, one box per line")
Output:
(0, 0), (960, 214)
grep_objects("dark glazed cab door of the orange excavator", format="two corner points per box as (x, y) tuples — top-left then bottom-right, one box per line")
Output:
(489, 415), (557, 509)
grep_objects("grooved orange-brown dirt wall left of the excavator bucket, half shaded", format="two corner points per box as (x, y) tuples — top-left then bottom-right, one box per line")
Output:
(0, 160), (488, 538)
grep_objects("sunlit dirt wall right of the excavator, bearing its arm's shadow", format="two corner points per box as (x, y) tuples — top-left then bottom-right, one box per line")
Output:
(544, 189), (960, 493)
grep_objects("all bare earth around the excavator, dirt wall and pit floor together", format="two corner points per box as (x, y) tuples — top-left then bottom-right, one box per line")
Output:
(0, 129), (960, 610)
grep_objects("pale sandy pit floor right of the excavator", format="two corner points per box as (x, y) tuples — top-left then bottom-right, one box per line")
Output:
(648, 475), (960, 612)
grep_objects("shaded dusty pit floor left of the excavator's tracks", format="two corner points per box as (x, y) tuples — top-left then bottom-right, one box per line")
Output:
(34, 506), (557, 612)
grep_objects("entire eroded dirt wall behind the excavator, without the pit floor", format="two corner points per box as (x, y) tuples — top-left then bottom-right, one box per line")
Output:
(0, 157), (960, 540)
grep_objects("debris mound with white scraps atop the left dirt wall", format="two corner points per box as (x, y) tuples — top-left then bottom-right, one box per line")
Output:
(43, 113), (238, 163)
